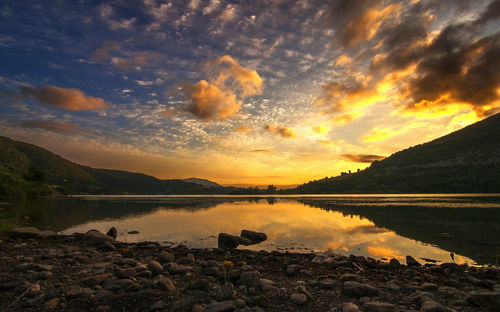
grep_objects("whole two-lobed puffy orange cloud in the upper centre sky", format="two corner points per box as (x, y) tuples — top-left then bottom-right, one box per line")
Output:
(182, 55), (262, 121)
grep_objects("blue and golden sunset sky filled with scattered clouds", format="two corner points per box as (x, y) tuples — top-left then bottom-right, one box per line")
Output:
(0, 0), (500, 186)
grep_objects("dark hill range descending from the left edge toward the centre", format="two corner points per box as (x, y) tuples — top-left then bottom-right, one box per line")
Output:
(0, 136), (235, 197)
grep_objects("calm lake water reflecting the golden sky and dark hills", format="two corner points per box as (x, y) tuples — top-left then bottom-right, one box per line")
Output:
(0, 195), (500, 264)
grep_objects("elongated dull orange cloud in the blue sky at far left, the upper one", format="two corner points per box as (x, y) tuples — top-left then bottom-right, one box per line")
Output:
(20, 86), (111, 111)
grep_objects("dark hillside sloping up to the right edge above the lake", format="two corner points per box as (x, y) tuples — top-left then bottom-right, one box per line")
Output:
(292, 114), (500, 194)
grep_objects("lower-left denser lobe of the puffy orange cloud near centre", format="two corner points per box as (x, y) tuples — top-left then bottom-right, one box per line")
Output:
(184, 80), (242, 121)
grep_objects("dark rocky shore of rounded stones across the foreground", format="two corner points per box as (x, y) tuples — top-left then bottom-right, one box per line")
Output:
(0, 228), (500, 312)
